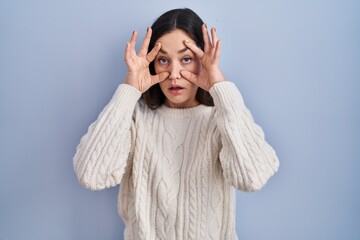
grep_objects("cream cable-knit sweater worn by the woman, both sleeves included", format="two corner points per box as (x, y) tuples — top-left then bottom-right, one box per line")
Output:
(74, 81), (279, 240)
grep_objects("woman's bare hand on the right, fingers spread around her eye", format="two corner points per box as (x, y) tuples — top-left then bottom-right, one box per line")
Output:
(180, 24), (225, 91)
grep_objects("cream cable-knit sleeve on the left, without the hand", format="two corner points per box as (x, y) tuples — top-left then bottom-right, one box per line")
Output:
(73, 84), (141, 190)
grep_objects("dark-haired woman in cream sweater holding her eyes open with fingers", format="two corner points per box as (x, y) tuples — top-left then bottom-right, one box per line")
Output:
(74, 9), (279, 239)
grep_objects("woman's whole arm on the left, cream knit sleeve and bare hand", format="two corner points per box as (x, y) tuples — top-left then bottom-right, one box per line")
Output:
(74, 28), (169, 190)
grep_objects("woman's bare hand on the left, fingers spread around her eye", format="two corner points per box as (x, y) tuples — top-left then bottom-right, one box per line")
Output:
(124, 28), (169, 93)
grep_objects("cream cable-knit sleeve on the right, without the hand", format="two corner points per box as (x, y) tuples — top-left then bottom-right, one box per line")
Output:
(210, 81), (279, 191)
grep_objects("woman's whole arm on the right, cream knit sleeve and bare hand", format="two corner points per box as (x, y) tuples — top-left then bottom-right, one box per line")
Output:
(181, 24), (279, 191)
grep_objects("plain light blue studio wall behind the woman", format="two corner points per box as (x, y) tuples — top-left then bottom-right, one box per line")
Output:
(0, 0), (360, 240)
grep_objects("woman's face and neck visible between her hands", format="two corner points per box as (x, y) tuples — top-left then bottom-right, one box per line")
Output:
(154, 29), (201, 108)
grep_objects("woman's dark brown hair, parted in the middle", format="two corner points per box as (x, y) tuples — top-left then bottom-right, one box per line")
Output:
(142, 8), (214, 109)
